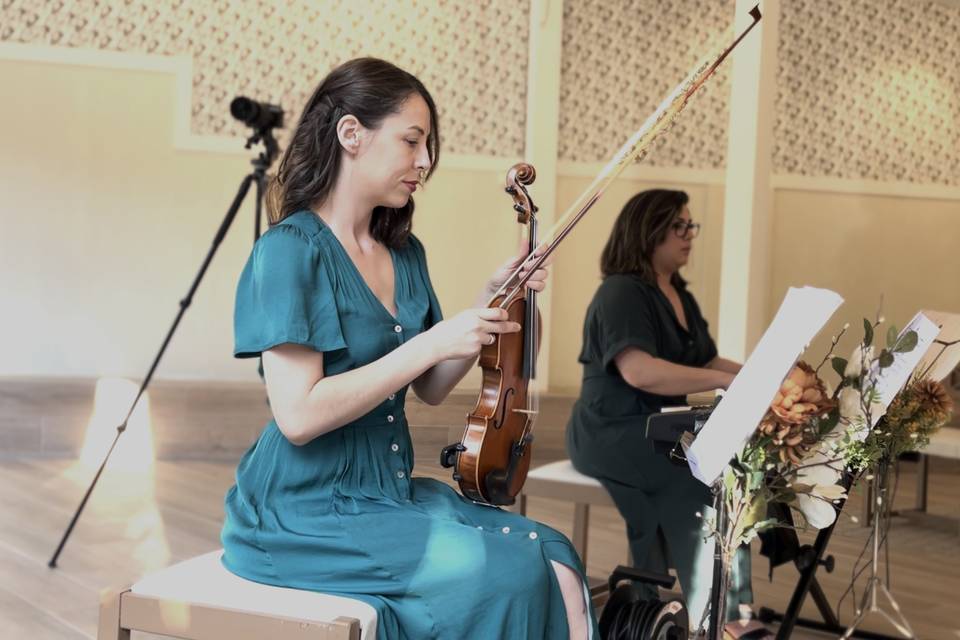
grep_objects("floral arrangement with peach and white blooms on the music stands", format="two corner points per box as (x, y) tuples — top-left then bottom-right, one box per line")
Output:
(704, 316), (953, 566)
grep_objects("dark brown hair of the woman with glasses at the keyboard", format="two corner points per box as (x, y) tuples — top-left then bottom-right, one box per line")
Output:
(600, 189), (690, 287)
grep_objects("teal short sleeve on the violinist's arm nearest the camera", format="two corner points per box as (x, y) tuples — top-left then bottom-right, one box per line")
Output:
(233, 224), (347, 358)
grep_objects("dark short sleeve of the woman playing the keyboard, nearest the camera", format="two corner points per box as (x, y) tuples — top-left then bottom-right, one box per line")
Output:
(596, 275), (658, 373)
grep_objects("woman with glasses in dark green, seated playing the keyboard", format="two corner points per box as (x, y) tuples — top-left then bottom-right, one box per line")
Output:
(567, 189), (764, 636)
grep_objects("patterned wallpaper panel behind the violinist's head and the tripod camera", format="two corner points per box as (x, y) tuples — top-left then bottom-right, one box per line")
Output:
(0, 0), (529, 155)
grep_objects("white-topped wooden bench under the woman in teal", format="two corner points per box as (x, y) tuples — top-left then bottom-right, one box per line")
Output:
(97, 550), (377, 640)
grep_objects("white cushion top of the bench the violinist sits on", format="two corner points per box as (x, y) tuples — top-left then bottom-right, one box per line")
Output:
(130, 549), (377, 640)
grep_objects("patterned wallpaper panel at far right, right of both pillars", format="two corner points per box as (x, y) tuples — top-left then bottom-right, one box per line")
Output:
(774, 0), (960, 186)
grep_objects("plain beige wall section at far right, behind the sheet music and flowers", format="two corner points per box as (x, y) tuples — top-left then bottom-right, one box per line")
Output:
(769, 190), (960, 382)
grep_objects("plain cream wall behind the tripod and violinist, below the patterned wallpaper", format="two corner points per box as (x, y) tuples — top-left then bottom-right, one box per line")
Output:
(0, 61), (517, 384)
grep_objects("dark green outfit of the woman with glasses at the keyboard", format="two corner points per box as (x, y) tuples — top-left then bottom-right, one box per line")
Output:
(567, 274), (752, 622)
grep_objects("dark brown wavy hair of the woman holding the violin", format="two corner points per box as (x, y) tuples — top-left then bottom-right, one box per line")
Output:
(267, 58), (440, 248)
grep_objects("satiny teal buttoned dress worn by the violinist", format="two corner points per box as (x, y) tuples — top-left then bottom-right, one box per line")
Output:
(221, 211), (598, 640)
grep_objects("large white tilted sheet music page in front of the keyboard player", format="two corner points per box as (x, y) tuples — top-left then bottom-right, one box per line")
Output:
(687, 287), (843, 485)
